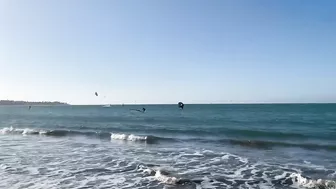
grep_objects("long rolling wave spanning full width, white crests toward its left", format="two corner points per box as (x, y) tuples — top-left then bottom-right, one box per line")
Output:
(0, 127), (336, 151)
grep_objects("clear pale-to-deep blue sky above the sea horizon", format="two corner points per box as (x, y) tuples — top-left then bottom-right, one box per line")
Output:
(0, 0), (336, 104)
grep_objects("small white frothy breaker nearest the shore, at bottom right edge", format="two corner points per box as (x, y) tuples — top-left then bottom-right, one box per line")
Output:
(137, 164), (336, 189)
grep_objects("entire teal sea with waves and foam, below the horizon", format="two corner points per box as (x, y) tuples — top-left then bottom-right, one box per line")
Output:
(0, 104), (336, 189)
